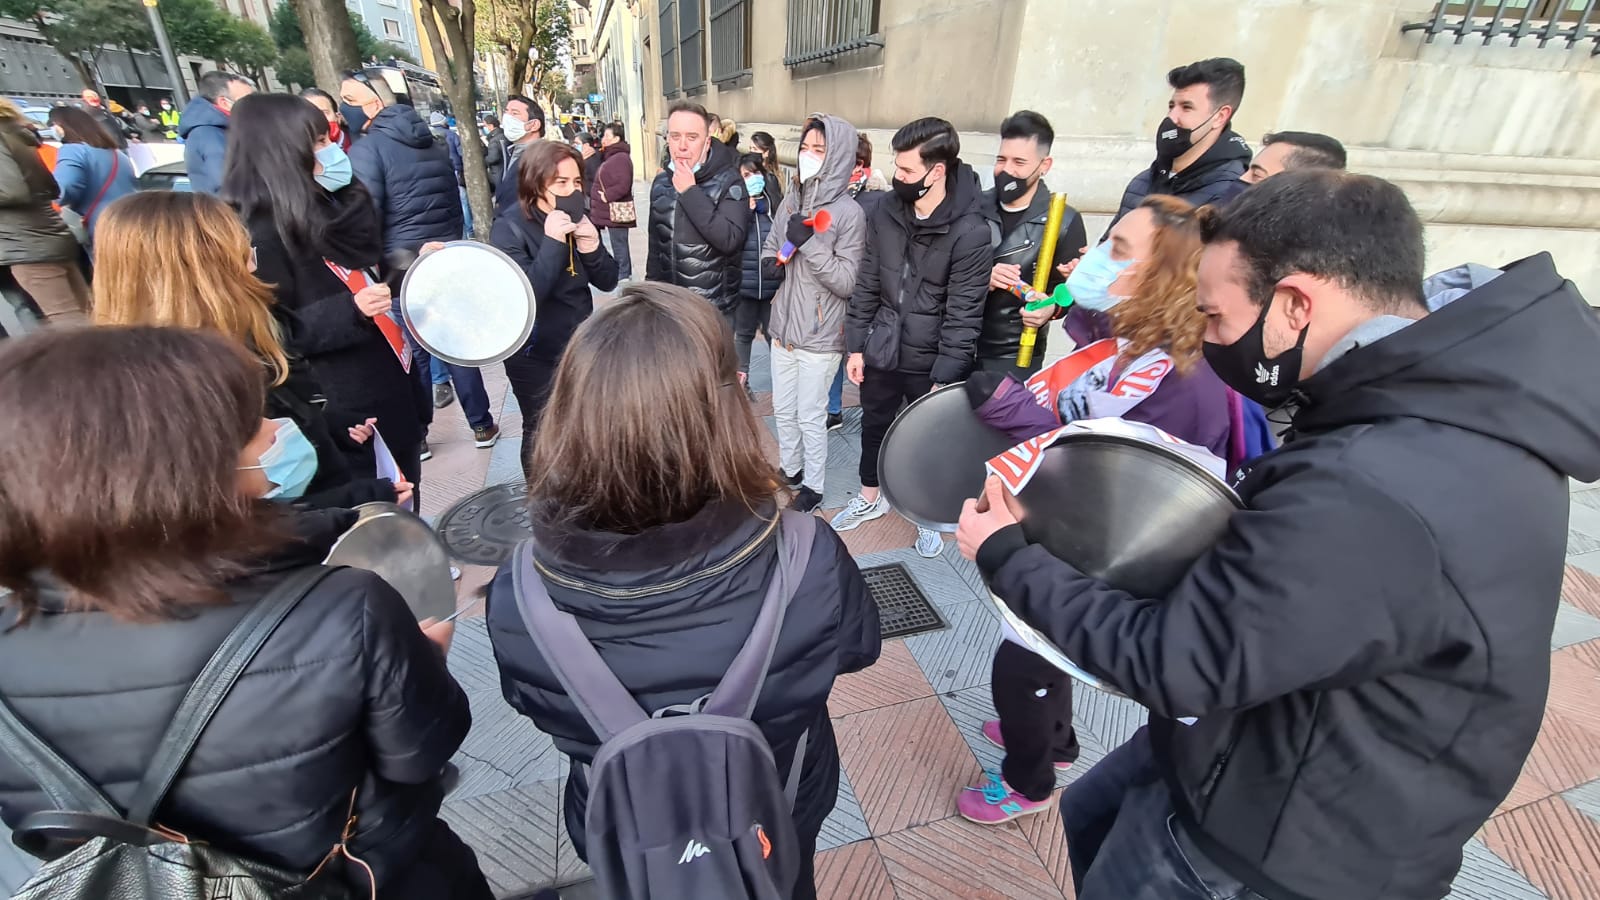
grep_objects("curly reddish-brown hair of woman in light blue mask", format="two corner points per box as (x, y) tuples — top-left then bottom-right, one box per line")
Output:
(1110, 195), (1205, 373)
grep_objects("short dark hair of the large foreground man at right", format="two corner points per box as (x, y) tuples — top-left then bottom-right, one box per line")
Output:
(1200, 168), (1427, 312)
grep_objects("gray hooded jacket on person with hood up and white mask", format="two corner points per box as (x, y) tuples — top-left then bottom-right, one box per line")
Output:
(762, 115), (867, 352)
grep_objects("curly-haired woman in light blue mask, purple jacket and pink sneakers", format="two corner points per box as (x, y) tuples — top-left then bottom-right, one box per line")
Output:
(957, 197), (1232, 825)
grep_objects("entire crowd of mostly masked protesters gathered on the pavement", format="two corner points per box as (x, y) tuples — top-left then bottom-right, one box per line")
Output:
(0, 50), (1600, 900)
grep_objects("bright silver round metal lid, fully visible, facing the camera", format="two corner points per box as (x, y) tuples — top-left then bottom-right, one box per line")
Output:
(400, 240), (536, 367)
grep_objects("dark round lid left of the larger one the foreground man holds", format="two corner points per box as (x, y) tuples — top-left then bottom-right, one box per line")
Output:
(878, 384), (1016, 532)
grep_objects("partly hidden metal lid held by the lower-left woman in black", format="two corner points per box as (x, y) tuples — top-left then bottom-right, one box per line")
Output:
(323, 503), (456, 621)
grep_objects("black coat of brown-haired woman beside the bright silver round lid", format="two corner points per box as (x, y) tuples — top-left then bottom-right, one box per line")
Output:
(490, 207), (618, 362)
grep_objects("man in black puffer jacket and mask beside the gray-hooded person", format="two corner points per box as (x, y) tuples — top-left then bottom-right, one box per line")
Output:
(834, 119), (994, 557)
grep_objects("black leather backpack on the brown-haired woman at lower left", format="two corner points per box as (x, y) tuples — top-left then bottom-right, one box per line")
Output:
(0, 565), (366, 900)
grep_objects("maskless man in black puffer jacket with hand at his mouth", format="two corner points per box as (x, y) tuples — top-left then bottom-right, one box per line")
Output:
(645, 101), (750, 315)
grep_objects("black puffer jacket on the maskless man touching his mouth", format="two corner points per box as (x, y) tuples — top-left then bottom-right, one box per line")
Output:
(645, 141), (750, 312)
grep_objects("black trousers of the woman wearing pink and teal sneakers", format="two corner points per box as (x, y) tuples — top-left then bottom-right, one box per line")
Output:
(989, 641), (1078, 801)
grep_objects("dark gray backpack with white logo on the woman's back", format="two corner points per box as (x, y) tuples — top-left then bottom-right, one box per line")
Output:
(514, 512), (816, 900)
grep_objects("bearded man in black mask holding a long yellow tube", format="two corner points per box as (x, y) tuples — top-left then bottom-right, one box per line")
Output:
(978, 109), (1088, 381)
